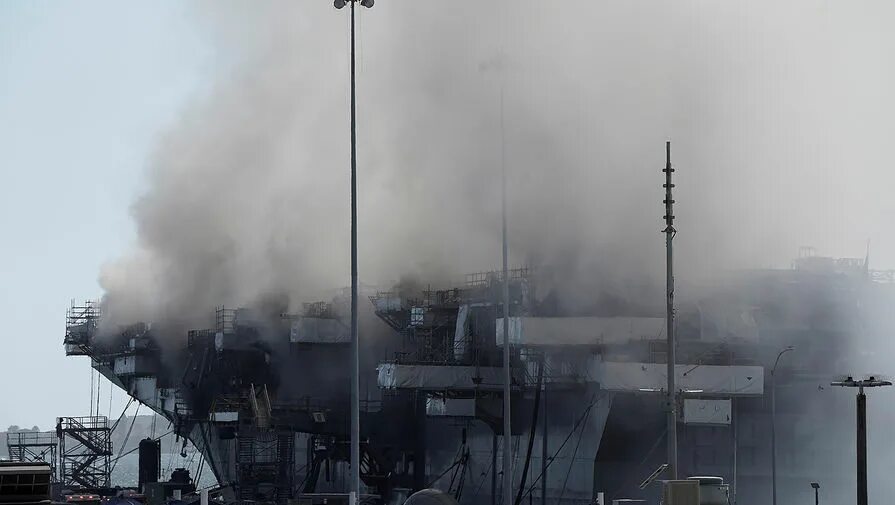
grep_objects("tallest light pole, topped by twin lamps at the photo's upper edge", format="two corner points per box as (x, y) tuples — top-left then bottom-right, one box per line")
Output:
(333, 0), (374, 505)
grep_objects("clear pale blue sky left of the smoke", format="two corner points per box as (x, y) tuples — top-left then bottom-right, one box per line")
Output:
(0, 1), (212, 430)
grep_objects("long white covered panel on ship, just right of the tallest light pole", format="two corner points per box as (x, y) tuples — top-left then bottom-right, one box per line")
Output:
(377, 363), (516, 391)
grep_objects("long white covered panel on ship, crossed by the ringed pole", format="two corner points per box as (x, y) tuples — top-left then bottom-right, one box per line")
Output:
(595, 361), (764, 395)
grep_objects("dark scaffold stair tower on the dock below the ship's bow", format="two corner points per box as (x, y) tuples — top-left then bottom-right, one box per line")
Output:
(56, 416), (112, 489)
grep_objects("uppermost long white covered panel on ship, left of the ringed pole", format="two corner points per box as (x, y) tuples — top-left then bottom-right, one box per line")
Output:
(496, 317), (665, 346)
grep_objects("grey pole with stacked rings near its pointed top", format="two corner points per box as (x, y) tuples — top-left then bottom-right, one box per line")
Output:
(662, 141), (677, 480)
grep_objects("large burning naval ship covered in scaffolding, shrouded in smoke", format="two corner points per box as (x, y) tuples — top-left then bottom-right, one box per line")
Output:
(65, 255), (893, 505)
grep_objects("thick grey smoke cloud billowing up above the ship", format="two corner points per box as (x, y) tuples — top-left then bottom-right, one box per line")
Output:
(101, 1), (890, 322)
